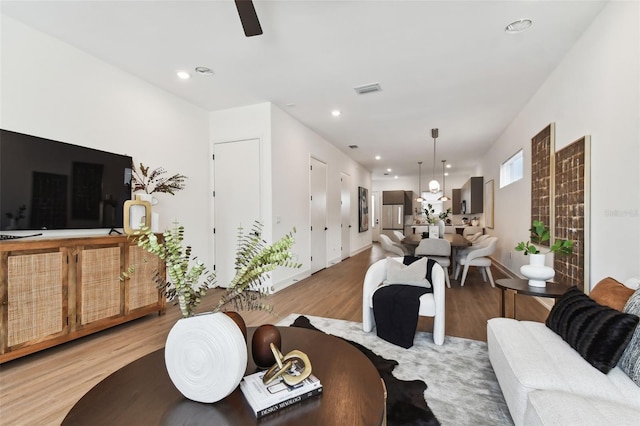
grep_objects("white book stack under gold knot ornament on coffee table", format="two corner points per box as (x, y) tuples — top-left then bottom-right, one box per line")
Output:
(240, 371), (322, 418)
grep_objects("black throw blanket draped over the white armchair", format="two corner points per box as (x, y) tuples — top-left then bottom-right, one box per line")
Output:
(373, 256), (436, 349)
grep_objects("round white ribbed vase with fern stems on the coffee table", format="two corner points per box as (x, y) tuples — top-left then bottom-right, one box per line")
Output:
(122, 222), (301, 403)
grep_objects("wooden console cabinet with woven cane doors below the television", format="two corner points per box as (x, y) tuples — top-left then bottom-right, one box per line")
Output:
(0, 236), (165, 363)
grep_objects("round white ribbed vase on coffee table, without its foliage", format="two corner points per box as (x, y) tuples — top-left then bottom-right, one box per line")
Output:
(164, 312), (247, 403)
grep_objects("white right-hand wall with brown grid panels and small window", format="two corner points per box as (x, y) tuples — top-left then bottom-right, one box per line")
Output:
(483, 2), (640, 287)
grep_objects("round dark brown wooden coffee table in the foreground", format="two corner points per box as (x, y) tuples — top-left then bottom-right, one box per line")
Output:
(62, 327), (385, 425)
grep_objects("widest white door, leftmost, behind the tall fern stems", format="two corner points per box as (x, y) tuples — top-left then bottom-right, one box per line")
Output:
(214, 139), (262, 287)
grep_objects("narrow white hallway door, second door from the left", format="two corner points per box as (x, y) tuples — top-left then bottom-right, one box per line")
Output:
(309, 158), (327, 274)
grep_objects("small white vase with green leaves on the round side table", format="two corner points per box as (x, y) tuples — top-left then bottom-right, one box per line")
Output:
(515, 220), (573, 287)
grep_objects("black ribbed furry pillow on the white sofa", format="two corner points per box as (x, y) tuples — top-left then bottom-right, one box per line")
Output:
(546, 287), (639, 374)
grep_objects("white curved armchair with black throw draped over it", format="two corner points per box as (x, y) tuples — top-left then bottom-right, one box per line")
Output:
(362, 257), (445, 345)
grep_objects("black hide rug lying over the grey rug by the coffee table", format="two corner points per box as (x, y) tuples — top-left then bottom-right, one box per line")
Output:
(291, 316), (440, 426)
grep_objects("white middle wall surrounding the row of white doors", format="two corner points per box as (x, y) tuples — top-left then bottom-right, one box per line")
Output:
(210, 103), (371, 289)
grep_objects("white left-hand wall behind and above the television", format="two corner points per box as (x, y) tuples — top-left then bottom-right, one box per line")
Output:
(0, 15), (209, 256)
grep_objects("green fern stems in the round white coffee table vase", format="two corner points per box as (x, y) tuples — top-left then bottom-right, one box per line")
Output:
(122, 222), (302, 317)
